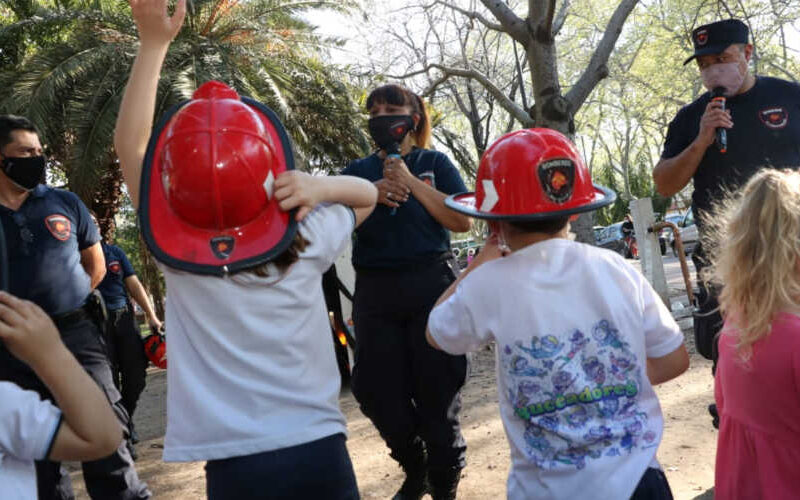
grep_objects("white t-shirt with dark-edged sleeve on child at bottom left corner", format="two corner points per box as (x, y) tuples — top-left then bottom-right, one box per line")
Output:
(0, 382), (61, 499)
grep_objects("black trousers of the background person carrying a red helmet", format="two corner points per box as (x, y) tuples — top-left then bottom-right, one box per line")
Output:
(108, 307), (148, 421)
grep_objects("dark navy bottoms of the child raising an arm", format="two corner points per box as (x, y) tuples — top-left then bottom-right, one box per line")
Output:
(206, 434), (359, 500)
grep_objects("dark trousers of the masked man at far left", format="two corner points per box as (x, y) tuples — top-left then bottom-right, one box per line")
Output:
(0, 316), (151, 500)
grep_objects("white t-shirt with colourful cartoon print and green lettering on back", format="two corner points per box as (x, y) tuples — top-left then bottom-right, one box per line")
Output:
(428, 239), (683, 499)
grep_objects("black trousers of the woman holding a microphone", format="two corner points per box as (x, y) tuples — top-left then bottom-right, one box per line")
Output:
(352, 261), (467, 468)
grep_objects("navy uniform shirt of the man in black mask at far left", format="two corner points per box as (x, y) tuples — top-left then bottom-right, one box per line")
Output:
(0, 184), (100, 314)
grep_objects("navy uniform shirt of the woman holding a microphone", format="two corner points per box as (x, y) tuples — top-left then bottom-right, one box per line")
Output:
(342, 149), (467, 268)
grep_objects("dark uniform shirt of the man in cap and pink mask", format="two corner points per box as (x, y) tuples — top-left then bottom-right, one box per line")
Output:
(661, 76), (800, 229)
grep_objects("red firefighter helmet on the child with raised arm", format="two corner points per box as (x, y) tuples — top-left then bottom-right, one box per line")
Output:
(139, 81), (297, 275)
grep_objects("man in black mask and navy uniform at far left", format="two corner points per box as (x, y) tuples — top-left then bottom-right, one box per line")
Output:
(0, 115), (151, 500)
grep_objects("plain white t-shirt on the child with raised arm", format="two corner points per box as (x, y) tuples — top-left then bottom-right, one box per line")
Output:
(161, 205), (355, 462)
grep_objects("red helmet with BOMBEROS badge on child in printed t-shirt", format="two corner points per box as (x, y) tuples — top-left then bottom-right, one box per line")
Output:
(445, 128), (617, 221)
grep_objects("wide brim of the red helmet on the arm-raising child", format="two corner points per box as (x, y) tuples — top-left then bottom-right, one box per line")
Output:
(139, 97), (297, 276)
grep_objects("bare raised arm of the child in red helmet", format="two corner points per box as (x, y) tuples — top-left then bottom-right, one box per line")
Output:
(114, 0), (186, 207)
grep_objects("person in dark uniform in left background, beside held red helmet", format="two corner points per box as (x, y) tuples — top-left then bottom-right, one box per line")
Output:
(92, 214), (161, 444)
